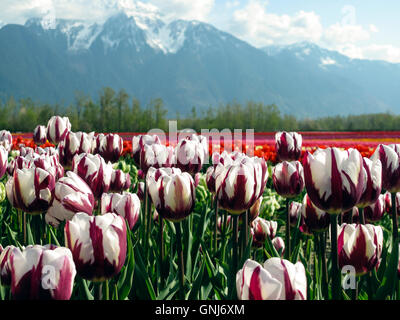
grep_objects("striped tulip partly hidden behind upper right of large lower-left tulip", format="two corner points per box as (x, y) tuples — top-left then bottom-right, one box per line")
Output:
(101, 192), (140, 230)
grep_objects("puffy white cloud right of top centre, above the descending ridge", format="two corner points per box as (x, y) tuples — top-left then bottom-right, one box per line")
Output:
(231, 0), (322, 47)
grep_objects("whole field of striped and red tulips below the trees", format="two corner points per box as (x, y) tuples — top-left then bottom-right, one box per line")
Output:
(0, 116), (400, 300)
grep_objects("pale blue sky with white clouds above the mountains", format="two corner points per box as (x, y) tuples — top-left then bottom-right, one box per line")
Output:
(0, 0), (400, 63)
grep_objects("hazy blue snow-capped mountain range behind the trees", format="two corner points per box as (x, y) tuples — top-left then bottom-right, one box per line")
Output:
(0, 10), (400, 116)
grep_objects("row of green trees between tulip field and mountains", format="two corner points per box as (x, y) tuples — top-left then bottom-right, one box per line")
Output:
(0, 87), (400, 132)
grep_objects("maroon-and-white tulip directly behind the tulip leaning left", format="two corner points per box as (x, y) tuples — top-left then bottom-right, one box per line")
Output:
(72, 153), (113, 199)
